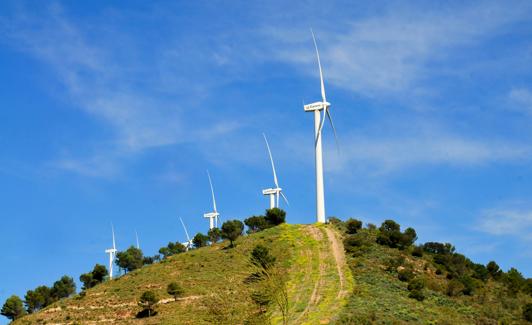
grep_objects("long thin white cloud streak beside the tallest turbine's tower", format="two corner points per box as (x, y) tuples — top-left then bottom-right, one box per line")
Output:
(326, 133), (532, 174)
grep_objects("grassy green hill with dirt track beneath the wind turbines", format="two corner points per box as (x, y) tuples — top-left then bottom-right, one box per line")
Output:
(7, 220), (532, 325)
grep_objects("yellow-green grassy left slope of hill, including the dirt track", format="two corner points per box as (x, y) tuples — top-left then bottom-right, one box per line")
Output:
(15, 224), (352, 324)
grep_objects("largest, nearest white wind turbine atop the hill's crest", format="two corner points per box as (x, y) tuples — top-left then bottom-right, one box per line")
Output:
(303, 29), (338, 223)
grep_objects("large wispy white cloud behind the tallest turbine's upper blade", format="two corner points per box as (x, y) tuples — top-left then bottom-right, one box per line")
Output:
(266, 2), (528, 97)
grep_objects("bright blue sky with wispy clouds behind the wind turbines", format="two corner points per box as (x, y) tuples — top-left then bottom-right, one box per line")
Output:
(0, 1), (532, 314)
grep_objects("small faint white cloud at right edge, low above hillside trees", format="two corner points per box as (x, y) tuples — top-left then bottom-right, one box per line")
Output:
(478, 207), (532, 241)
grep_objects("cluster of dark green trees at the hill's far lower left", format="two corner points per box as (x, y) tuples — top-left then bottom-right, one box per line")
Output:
(1, 275), (76, 320)
